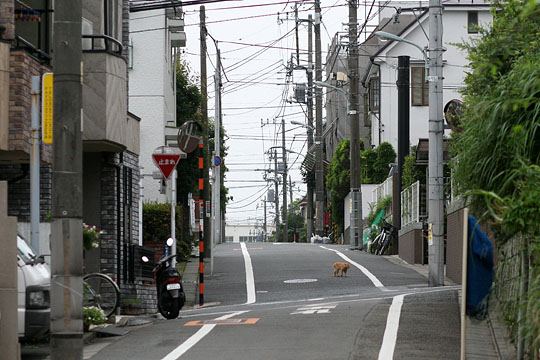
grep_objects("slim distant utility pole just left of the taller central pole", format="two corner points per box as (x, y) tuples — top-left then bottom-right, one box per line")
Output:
(306, 14), (313, 242)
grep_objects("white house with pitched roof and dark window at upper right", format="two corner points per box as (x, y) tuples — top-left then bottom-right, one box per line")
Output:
(367, 0), (491, 149)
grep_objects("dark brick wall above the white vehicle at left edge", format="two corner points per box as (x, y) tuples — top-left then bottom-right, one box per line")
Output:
(0, 164), (52, 222)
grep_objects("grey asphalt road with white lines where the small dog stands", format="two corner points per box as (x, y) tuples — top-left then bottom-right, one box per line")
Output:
(87, 243), (459, 360)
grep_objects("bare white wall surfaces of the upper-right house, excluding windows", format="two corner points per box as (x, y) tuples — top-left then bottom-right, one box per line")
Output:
(371, 8), (491, 149)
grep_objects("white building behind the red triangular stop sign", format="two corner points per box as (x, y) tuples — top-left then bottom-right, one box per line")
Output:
(129, 8), (186, 202)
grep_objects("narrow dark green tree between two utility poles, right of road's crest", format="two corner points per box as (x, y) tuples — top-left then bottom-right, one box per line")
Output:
(326, 140), (350, 233)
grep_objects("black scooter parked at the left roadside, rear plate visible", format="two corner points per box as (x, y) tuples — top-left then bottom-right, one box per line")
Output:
(142, 239), (186, 319)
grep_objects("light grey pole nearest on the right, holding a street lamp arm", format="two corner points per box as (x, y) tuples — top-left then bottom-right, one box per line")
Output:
(428, 0), (444, 286)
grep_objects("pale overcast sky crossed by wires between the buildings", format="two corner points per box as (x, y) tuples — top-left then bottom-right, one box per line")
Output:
(180, 0), (392, 223)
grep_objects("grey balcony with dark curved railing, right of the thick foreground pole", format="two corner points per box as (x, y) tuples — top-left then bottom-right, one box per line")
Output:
(82, 35), (139, 153)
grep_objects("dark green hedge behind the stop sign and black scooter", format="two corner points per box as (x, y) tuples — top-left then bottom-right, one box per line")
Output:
(143, 202), (193, 260)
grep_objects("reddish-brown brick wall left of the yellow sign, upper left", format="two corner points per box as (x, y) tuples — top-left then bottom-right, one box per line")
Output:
(9, 50), (52, 163)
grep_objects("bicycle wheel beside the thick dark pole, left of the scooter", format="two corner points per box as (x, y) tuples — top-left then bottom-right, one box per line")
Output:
(83, 273), (120, 317)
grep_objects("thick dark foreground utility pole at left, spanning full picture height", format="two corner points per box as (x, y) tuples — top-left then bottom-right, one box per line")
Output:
(51, 0), (83, 360)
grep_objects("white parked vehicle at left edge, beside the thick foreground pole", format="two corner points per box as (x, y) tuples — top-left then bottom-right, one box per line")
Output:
(17, 235), (51, 340)
